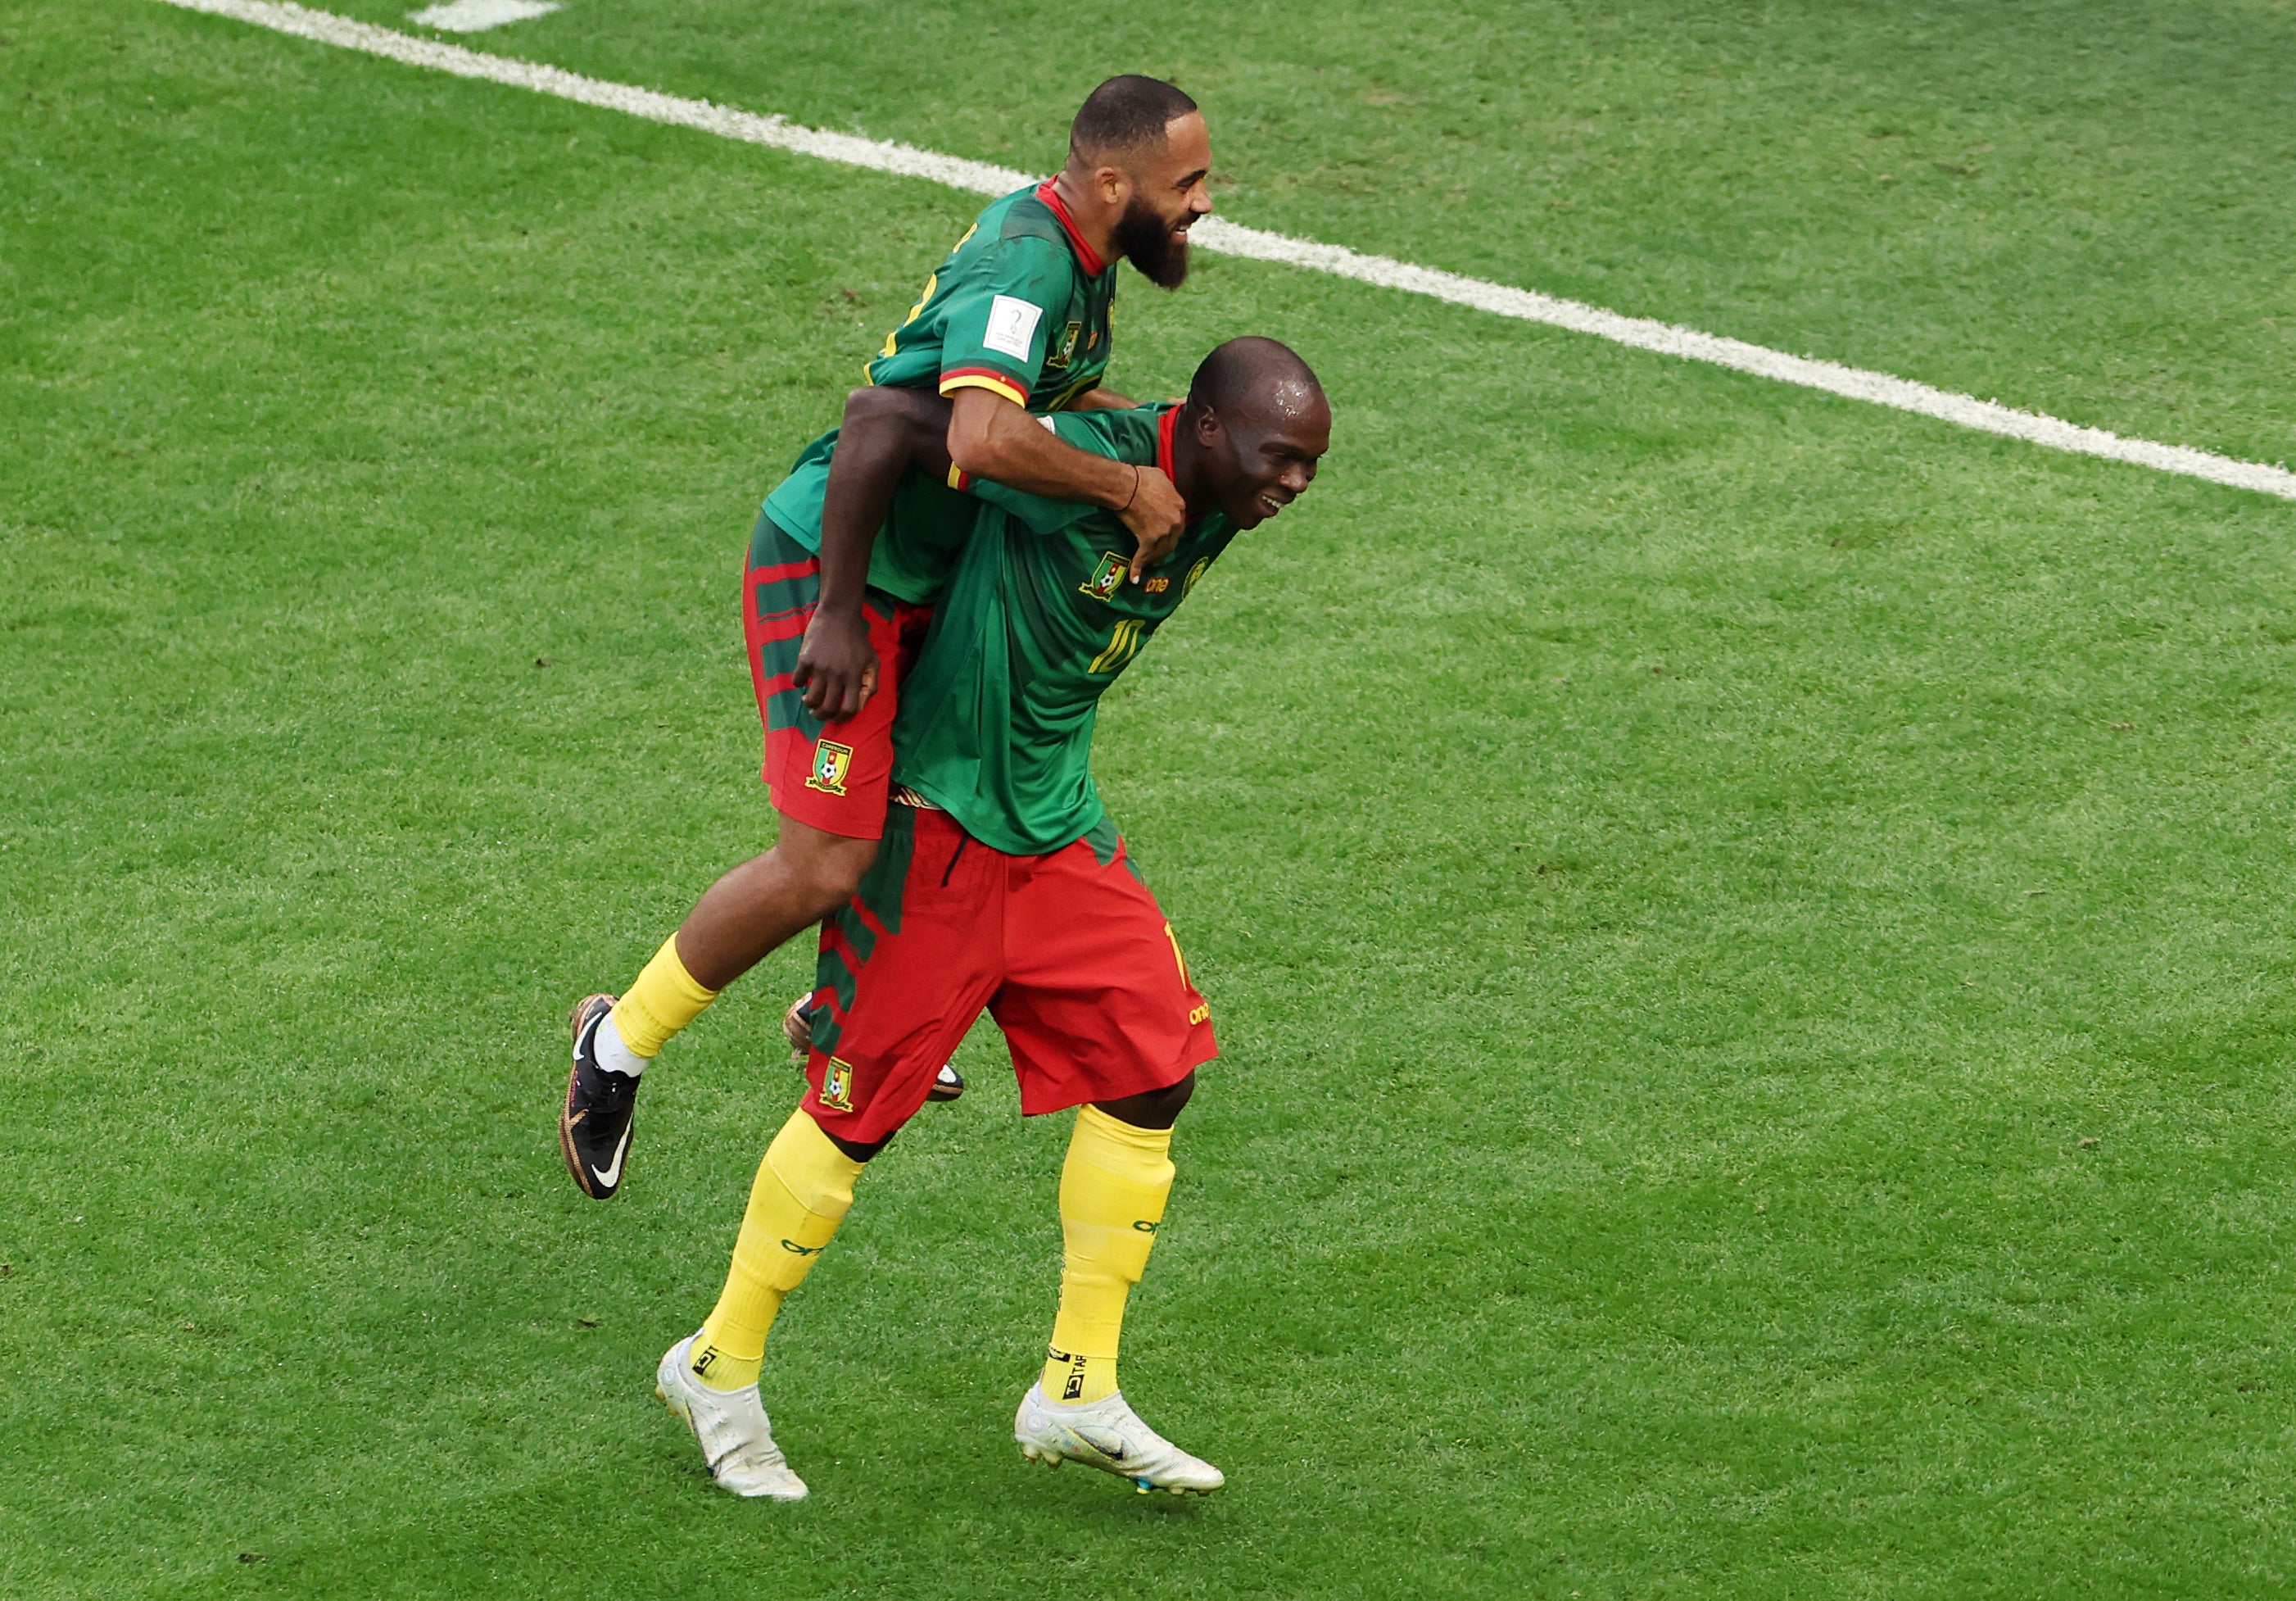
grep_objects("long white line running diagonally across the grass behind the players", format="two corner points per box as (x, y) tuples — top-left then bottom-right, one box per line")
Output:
(161, 0), (2296, 501)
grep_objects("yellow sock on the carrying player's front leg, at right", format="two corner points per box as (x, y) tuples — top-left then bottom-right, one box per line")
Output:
(1044, 1107), (1173, 1401)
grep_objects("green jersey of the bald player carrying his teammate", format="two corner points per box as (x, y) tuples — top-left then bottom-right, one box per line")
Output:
(893, 404), (1235, 857)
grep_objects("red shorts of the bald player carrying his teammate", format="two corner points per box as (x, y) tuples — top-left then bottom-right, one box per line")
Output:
(804, 804), (1219, 1144)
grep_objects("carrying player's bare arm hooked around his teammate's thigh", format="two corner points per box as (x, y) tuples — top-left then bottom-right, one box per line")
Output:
(790, 388), (950, 723)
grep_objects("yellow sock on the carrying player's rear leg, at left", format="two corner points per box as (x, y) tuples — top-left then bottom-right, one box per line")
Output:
(694, 1107), (861, 1390)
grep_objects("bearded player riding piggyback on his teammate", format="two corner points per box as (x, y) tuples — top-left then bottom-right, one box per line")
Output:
(558, 76), (1212, 1201)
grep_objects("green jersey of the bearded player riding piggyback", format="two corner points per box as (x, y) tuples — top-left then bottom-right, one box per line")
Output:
(764, 184), (1120, 604)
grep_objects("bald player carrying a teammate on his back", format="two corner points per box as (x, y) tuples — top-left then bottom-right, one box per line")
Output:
(657, 340), (1332, 1500)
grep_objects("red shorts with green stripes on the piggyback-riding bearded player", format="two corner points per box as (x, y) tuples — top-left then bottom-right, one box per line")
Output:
(741, 515), (932, 838)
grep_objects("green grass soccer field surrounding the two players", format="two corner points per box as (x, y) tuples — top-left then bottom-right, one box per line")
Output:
(0, 0), (2296, 1601)
